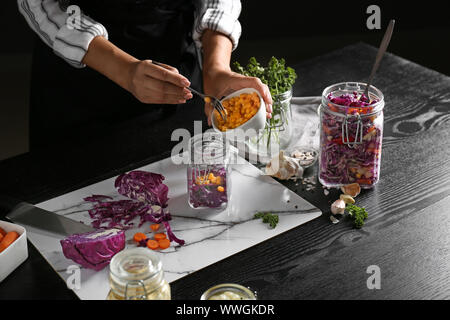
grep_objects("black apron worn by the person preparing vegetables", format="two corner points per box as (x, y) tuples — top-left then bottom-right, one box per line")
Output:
(30, 0), (204, 151)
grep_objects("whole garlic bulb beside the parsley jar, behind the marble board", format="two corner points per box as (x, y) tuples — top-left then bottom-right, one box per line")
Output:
(266, 151), (303, 180)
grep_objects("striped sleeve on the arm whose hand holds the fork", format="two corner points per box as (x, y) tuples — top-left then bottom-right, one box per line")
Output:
(17, 0), (108, 68)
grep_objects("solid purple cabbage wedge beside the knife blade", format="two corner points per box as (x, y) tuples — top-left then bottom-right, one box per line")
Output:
(60, 229), (125, 271)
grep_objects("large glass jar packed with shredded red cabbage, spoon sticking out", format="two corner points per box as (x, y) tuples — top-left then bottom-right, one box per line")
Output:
(319, 82), (384, 189)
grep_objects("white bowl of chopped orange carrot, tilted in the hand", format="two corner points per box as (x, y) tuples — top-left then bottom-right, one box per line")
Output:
(211, 88), (266, 140)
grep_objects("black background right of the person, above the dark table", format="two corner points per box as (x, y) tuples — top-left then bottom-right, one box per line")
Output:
(235, 0), (450, 75)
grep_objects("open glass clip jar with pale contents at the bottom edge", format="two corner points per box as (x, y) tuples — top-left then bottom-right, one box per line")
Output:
(107, 248), (170, 300)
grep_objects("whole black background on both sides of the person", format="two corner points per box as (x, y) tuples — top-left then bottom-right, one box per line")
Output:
(0, 0), (450, 160)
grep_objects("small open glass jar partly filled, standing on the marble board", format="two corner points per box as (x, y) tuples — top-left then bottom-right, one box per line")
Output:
(187, 132), (231, 210)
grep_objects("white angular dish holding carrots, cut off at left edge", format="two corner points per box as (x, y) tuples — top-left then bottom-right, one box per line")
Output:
(0, 220), (28, 282)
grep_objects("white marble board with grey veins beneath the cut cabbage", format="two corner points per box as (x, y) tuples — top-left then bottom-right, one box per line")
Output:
(27, 97), (321, 299)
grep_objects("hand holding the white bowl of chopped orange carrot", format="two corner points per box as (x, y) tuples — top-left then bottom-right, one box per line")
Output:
(203, 69), (272, 125)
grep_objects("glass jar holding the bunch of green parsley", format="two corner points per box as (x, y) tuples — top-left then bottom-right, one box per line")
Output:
(249, 88), (292, 158)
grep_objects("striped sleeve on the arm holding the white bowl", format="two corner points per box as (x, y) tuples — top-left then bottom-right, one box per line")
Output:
(192, 0), (241, 50)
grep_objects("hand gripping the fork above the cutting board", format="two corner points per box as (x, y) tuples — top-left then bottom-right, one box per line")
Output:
(127, 60), (192, 104)
